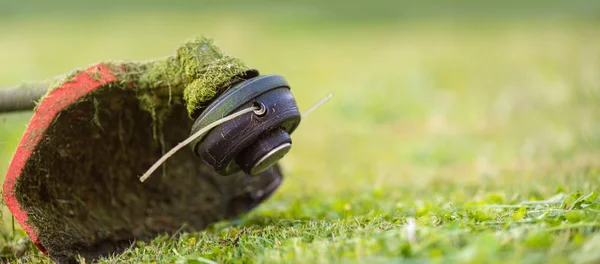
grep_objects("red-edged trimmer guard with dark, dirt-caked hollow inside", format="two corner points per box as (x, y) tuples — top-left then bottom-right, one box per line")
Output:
(4, 63), (282, 263)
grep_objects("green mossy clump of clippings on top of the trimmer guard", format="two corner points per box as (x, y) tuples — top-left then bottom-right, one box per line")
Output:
(105, 38), (250, 116)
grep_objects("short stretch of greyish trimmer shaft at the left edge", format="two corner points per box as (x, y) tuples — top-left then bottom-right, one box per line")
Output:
(0, 84), (48, 113)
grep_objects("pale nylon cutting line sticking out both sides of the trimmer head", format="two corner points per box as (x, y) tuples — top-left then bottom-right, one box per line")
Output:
(140, 94), (333, 182)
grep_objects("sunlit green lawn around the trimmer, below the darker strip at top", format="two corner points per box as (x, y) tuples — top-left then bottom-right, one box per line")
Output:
(0, 9), (600, 263)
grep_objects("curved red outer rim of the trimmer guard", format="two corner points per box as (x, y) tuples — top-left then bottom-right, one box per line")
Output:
(4, 63), (117, 254)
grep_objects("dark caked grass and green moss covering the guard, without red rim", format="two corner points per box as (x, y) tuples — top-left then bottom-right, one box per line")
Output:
(15, 38), (281, 262)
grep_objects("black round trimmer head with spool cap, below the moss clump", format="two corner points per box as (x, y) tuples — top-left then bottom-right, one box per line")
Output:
(192, 75), (301, 175)
